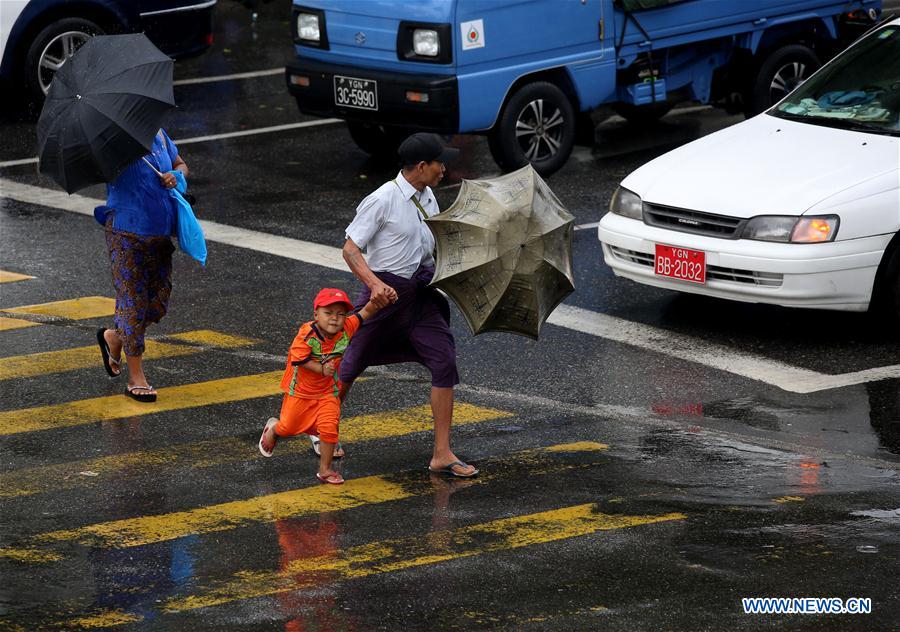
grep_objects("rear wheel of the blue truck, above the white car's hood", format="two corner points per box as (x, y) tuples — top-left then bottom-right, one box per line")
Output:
(747, 44), (822, 116)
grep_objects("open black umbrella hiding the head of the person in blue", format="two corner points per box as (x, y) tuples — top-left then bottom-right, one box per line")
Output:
(37, 34), (175, 193)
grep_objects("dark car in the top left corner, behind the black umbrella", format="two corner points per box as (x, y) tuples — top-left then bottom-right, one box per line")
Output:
(0, 0), (217, 105)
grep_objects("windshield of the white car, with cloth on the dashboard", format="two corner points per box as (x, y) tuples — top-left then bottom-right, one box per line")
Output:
(769, 24), (900, 136)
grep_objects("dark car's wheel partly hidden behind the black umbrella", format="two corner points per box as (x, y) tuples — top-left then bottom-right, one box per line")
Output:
(23, 18), (103, 105)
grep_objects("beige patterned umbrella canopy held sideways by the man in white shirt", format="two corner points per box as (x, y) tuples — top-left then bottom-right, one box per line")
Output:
(427, 165), (575, 339)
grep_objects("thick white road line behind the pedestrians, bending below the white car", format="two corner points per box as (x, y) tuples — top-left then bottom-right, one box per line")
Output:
(0, 179), (900, 393)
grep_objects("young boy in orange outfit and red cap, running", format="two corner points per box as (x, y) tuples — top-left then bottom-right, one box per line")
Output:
(259, 288), (378, 485)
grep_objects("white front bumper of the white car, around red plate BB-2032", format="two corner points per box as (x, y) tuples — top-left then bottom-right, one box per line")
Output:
(597, 213), (892, 311)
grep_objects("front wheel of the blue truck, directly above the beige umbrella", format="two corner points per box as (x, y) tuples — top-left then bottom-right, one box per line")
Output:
(488, 81), (575, 176)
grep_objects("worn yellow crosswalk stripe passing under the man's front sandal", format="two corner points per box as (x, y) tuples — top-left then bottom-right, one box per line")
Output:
(0, 441), (609, 562)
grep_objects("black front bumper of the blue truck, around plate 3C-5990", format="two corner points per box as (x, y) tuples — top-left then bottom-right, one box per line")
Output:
(285, 58), (459, 134)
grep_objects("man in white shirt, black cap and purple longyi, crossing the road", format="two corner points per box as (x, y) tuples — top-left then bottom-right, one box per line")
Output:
(339, 133), (478, 478)
